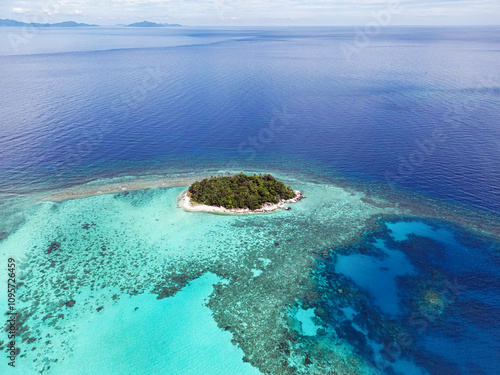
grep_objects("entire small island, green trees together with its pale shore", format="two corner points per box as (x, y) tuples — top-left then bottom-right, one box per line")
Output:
(180, 173), (304, 213)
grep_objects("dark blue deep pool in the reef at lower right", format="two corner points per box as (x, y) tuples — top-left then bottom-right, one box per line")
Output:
(318, 219), (500, 375)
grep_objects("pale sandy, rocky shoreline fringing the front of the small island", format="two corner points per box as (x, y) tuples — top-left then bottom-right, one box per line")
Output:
(178, 190), (305, 214)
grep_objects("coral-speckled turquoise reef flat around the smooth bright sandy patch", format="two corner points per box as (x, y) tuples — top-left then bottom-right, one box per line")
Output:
(0, 177), (498, 374)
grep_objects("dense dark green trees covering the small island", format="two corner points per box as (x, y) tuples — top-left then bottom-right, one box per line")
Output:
(189, 173), (295, 210)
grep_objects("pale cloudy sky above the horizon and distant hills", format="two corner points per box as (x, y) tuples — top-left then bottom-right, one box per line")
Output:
(0, 0), (500, 26)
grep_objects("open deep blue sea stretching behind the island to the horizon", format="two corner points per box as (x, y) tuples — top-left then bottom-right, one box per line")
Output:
(0, 27), (500, 213)
